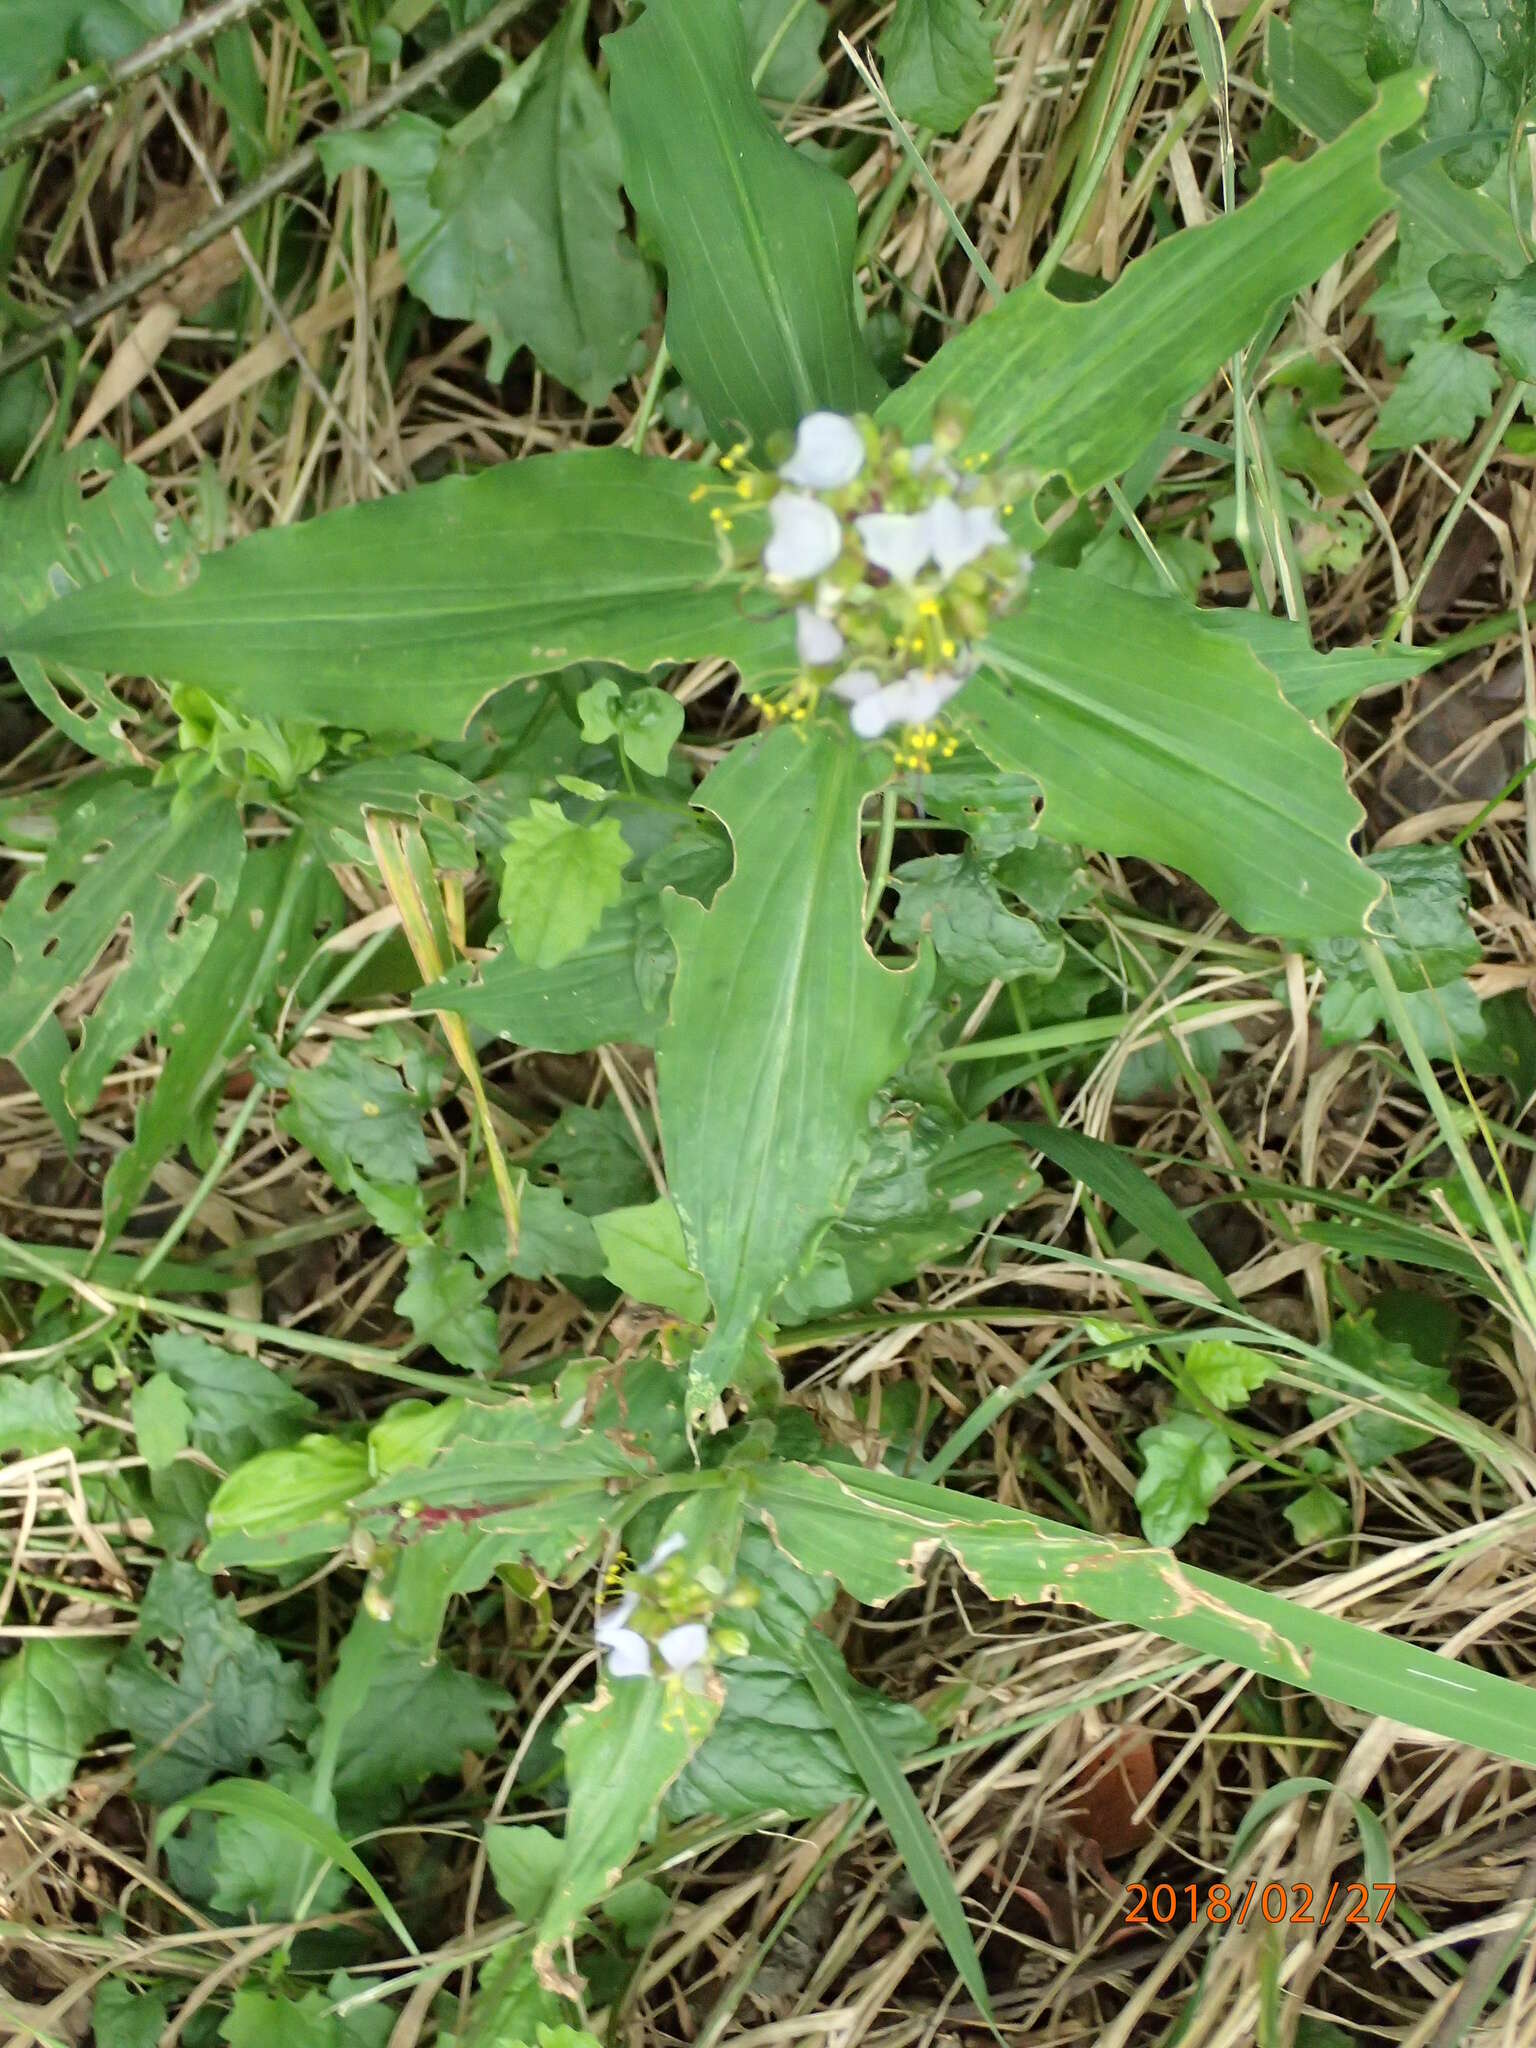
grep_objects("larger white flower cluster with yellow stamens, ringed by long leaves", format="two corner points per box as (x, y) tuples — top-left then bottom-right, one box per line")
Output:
(696, 412), (1030, 768)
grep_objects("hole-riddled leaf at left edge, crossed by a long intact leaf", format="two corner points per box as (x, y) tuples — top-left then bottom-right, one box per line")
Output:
(0, 438), (195, 766)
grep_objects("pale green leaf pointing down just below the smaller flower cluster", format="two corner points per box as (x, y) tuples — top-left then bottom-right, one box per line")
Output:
(532, 1677), (721, 1997)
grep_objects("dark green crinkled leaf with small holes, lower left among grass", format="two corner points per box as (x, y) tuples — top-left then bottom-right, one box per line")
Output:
(106, 1561), (313, 1806)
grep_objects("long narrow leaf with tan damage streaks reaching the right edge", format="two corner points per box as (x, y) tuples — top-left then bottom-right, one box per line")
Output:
(748, 1464), (1536, 1763)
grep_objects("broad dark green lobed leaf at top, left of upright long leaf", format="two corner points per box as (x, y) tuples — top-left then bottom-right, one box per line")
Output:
(319, 4), (653, 406)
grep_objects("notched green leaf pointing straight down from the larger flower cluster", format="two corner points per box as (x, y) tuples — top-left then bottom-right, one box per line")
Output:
(657, 725), (930, 1409)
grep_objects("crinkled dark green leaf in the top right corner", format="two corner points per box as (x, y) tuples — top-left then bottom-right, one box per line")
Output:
(1366, 0), (1536, 184)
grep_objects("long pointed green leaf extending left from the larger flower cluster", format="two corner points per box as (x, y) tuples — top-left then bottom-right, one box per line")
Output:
(0, 449), (795, 739)
